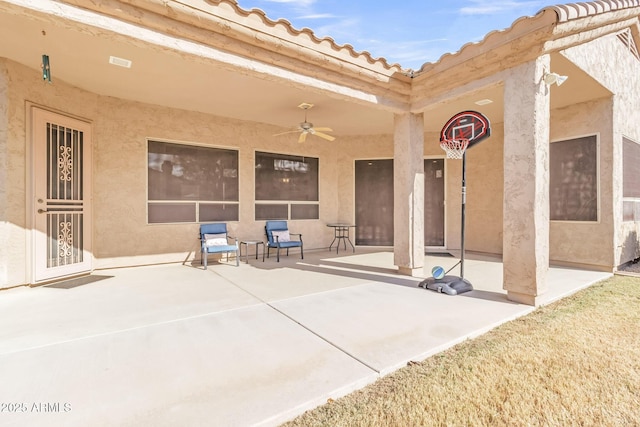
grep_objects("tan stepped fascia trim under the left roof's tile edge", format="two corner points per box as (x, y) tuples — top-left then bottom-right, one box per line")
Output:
(112, 0), (409, 88)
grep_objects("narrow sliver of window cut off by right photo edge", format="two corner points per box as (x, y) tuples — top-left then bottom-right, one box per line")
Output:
(622, 138), (640, 221)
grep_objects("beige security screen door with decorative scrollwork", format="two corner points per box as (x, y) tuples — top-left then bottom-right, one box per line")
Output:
(32, 107), (91, 282)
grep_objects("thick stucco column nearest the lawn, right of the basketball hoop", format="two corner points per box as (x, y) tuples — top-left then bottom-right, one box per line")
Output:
(503, 55), (550, 305)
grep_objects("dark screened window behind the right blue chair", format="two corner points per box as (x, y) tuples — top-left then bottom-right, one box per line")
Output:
(255, 151), (320, 220)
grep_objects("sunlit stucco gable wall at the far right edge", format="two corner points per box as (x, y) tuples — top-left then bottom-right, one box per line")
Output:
(564, 31), (640, 267)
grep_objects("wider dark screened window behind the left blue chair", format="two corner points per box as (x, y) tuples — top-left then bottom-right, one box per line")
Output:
(147, 141), (239, 224)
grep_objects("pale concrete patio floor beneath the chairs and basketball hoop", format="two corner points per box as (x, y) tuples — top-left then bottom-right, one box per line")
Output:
(0, 248), (611, 427)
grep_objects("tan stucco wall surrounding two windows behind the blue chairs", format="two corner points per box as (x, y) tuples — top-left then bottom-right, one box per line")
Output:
(94, 97), (347, 268)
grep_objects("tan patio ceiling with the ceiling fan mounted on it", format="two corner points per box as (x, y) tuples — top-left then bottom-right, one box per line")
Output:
(0, 2), (606, 136)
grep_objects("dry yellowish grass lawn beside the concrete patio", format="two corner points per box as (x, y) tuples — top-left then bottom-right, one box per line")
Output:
(285, 276), (640, 427)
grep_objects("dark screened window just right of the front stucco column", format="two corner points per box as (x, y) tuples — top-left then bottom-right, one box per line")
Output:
(549, 135), (598, 221)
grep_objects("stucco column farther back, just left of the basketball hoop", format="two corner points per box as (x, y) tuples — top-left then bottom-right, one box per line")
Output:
(393, 113), (424, 277)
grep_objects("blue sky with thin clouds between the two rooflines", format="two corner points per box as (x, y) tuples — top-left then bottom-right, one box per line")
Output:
(238, 0), (570, 70)
